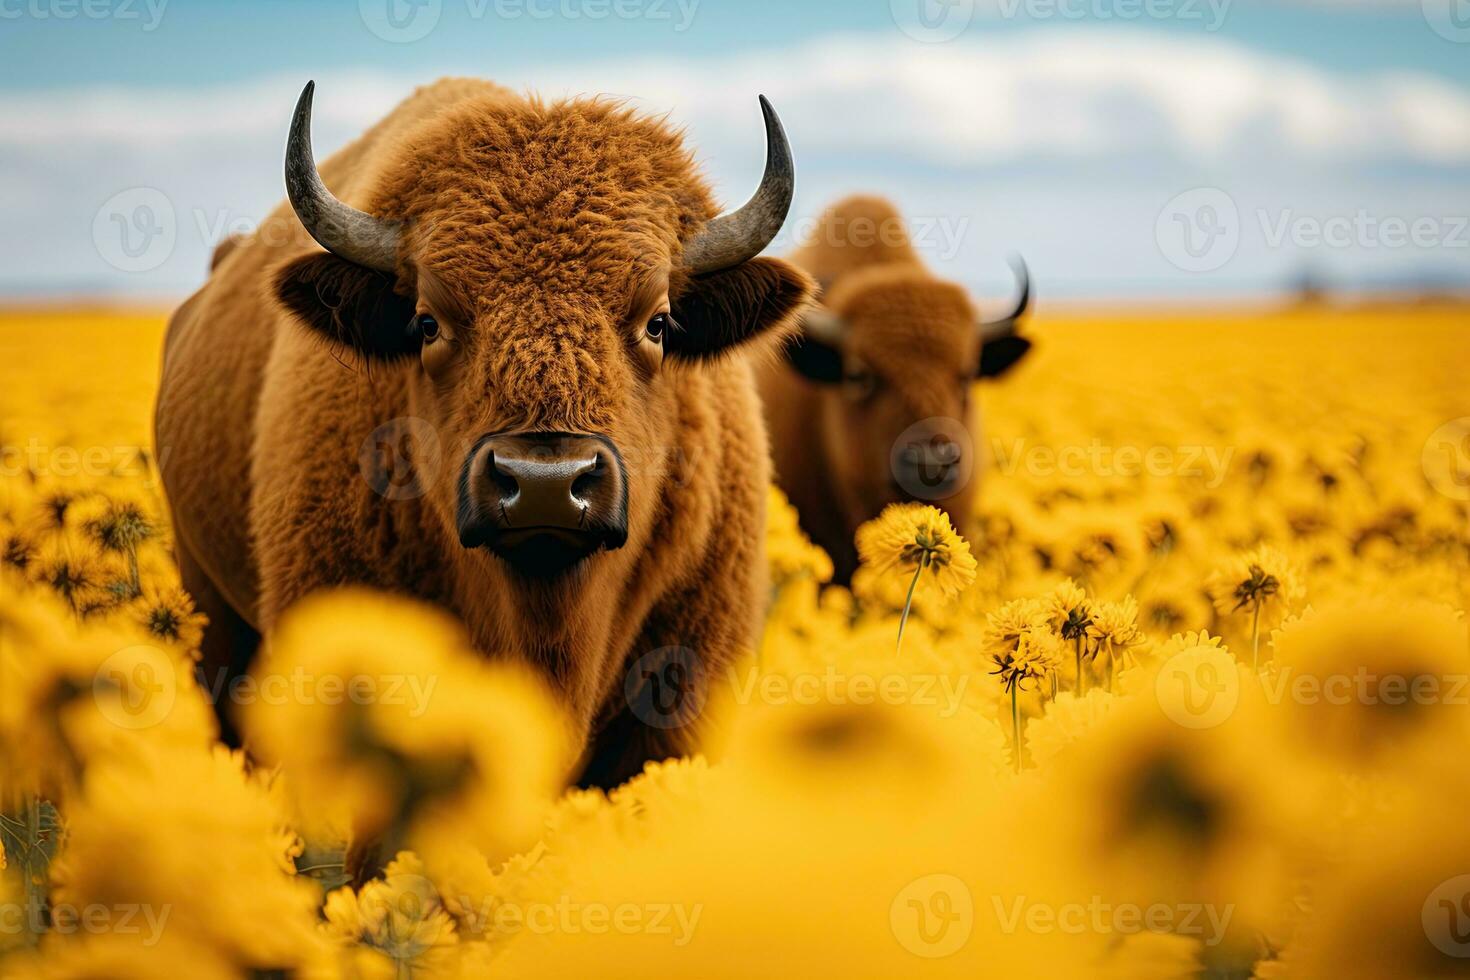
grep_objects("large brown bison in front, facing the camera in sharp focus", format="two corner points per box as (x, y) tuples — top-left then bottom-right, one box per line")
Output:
(156, 79), (813, 785)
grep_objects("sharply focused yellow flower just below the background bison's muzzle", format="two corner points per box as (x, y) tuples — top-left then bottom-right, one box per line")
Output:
(857, 504), (976, 597)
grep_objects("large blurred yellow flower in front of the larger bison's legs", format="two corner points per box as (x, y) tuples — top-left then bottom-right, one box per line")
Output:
(244, 589), (572, 861)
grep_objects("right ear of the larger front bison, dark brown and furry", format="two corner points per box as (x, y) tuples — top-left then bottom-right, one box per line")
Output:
(664, 259), (816, 360)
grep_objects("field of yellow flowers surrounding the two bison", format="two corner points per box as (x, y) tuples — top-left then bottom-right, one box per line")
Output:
(0, 306), (1470, 980)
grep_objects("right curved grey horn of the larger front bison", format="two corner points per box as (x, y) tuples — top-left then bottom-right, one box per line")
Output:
(684, 96), (795, 275)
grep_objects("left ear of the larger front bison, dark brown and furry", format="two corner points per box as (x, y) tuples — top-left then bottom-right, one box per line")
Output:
(275, 253), (420, 360)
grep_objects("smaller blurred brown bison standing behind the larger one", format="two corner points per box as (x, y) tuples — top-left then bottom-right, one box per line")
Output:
(760, 197), (1030, 583)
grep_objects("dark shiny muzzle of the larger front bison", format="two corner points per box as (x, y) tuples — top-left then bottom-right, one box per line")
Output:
(459, 432), (628, 574)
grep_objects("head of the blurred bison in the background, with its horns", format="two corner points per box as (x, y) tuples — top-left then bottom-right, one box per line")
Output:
(786, 259), (1030, 526)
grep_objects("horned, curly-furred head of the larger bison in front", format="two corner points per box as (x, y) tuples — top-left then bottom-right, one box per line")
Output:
(276, 84), (811, 577)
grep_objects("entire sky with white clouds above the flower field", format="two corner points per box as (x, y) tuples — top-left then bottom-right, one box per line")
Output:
(0, 0), (1470, 298)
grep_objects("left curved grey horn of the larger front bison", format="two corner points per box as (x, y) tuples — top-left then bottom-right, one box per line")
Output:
(285, 81), (398, 272)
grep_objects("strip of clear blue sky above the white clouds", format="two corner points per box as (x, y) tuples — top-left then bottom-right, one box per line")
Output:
(0, 0), (1470, 93)
